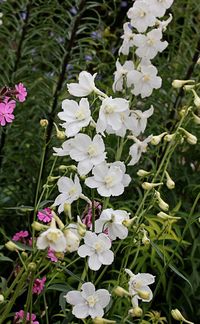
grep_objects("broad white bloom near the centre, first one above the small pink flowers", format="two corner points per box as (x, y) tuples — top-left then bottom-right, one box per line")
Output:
(85, 162), (130, 197)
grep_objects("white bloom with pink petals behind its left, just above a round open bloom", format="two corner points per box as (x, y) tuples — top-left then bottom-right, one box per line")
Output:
(95, 208), (129, 240)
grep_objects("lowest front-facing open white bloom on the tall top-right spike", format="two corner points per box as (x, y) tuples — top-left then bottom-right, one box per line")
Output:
(127, 65), (162, 98)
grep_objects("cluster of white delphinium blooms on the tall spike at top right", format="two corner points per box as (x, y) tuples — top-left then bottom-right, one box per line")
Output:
(113, 0), (174, 98)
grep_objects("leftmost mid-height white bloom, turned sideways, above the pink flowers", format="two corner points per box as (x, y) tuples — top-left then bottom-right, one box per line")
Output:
(53, 175), (82, 213)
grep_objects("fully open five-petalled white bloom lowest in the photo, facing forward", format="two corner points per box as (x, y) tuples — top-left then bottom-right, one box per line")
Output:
(64, 282), (110, 318)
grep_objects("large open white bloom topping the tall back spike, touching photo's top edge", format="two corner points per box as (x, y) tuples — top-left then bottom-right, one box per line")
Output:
(127, 0), (156, 33)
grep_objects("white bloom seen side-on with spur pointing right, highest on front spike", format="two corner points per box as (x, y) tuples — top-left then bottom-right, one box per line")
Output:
(67, 71), (106, 97)
